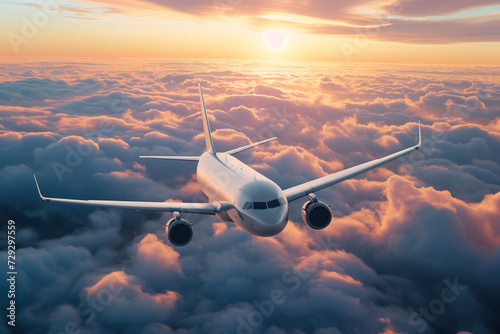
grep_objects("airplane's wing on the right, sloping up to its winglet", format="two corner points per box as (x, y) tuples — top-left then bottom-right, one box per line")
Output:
(283, 123), (422, 202)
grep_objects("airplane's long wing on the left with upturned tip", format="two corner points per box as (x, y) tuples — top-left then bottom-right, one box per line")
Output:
(33, 175), (217, 215)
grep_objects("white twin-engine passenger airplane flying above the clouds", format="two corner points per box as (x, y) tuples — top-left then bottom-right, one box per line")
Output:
(34, 84), (422, 246)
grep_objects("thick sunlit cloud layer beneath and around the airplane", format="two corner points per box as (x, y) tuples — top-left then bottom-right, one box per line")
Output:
(0, 58), (500, 334)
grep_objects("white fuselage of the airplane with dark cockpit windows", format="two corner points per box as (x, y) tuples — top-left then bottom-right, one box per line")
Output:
(196, 152), (288, 237)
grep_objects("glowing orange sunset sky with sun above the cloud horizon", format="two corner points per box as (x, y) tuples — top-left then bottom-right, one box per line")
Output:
(0, 0), (500, 65)
